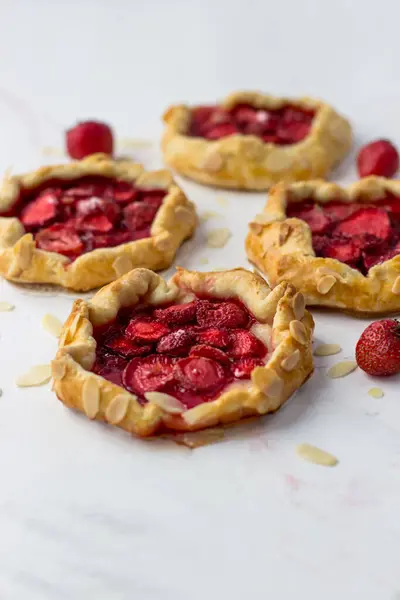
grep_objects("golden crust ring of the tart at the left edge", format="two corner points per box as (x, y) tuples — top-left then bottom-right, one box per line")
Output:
(0, 154), (197, 291)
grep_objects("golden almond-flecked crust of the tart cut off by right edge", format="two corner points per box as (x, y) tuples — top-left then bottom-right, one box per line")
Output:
(246, 177), (400, 315)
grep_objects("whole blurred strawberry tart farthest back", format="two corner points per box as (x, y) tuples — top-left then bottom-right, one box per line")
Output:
(162, 92), (352, 190)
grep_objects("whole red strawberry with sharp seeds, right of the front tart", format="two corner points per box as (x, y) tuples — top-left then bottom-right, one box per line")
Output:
(356, 319), (400, 375)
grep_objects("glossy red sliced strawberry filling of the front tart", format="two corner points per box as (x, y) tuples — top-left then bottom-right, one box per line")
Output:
(93, 298), (271, 408)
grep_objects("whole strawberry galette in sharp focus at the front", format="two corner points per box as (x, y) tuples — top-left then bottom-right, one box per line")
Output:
(52, 269), (313, 436)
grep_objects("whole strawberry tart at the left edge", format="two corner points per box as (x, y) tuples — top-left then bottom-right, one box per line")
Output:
(0, 154), (196, 291)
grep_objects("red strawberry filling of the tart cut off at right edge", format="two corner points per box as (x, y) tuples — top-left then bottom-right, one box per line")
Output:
(287, 195), (400, 274)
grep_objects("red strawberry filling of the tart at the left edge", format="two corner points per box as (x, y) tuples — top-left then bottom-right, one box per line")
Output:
(0, 177), (166, 260)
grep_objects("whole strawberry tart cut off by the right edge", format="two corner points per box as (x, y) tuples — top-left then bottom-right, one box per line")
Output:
(246, 177), (400, 315)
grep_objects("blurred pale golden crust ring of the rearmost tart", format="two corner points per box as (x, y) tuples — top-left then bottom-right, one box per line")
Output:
(161, 92), (352, 190)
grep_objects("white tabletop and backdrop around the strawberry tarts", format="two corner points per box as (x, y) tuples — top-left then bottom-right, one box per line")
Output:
(0, 0), (400, 600)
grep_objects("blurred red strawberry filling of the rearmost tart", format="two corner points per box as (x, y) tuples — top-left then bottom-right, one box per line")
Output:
(189, 104), (315, 145)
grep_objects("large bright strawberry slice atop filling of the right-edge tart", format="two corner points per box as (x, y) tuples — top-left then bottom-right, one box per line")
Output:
(333, 206), (391, 240)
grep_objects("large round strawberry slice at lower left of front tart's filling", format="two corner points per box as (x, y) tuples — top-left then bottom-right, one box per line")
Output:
(122, 354), (174, 396)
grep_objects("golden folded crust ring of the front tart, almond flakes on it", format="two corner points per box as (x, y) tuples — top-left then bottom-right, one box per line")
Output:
(52, 269), (314, 436)
